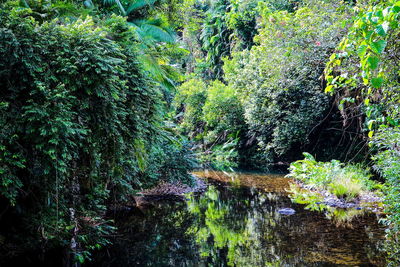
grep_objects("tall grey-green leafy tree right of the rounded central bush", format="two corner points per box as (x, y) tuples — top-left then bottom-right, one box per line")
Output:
(225, 0), (352, 161)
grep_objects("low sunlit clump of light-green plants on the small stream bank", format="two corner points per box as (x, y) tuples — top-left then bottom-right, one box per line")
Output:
(288, 153), (379, 201)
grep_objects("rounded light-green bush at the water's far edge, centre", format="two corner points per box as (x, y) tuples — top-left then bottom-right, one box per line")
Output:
(175, 79), (246, 168)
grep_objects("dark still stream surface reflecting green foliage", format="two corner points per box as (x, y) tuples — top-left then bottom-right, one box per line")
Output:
(88, 173), (385, 266)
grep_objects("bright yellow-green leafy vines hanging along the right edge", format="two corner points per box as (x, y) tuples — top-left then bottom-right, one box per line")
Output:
(326, 1), (400, 262)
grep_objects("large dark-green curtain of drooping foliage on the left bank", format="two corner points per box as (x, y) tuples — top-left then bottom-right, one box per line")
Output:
(0, 2), (193, 261)
